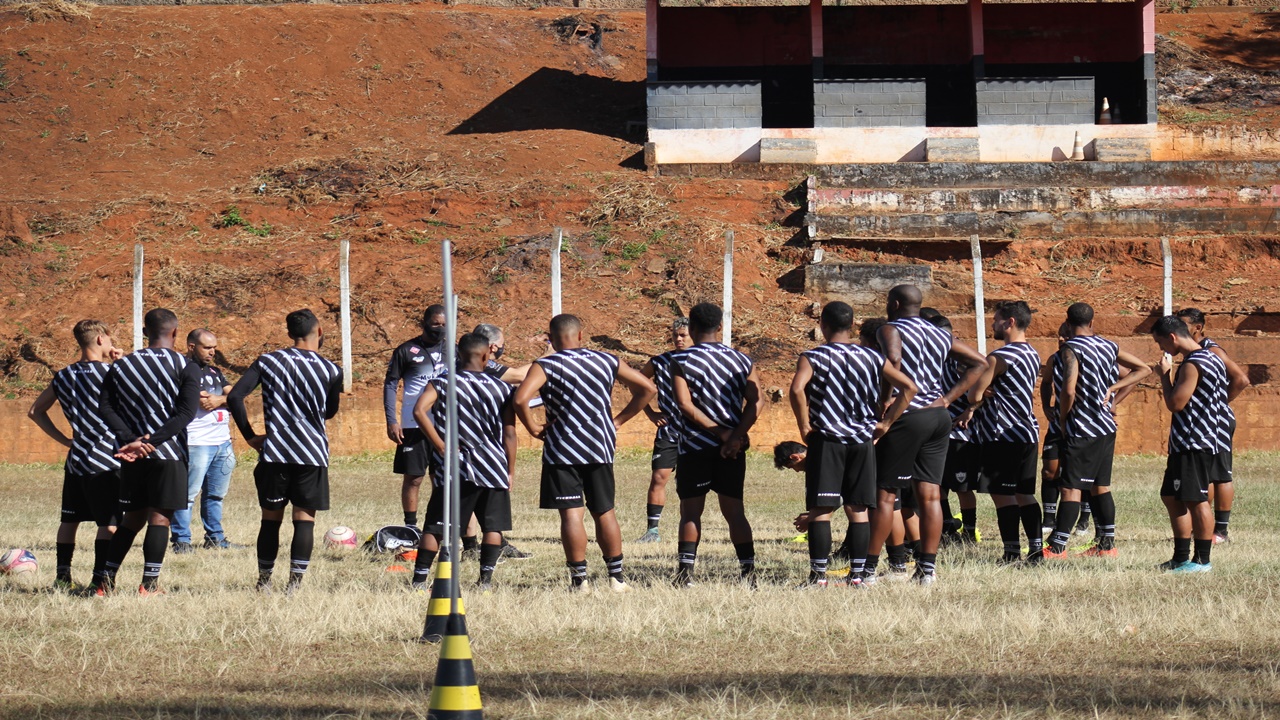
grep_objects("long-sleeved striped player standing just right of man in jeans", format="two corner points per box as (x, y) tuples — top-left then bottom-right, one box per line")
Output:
(227, 304), (342, 592)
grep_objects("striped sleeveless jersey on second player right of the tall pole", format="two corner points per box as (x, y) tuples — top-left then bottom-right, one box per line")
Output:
(534, 347), (618, 465)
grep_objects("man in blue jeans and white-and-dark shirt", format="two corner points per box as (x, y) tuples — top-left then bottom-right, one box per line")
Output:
(173, 328), (246, 553)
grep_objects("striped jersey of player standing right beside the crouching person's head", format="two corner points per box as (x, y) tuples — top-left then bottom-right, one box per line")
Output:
(803, 342), (884, 445)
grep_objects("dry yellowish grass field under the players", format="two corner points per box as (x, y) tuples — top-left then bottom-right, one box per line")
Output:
(0, 455), (1280, 719)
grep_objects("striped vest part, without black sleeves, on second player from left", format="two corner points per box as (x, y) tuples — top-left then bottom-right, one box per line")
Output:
(108, 347), (187, 462)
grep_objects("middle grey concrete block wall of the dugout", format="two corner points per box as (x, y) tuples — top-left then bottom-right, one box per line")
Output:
(813, 78), (924, 128)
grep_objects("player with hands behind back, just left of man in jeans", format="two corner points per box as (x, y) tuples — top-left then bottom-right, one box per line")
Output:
(93, 309), (200, 596)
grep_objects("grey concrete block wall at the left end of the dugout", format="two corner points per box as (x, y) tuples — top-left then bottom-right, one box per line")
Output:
(646, 82), (762, 129)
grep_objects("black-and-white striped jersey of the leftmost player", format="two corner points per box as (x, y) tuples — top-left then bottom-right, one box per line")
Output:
(50, 363), (120, 475)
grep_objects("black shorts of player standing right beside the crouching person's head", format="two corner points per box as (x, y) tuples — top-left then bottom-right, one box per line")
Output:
(803, 434), (876, 510)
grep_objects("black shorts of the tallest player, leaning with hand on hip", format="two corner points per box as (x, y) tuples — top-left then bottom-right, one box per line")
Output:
(876, 407), (951, 489)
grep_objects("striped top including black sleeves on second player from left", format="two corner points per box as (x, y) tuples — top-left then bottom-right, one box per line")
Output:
(99, 347), (200, 462)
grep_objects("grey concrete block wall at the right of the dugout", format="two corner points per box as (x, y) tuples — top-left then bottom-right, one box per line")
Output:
(978, 77), (1094, 126)
